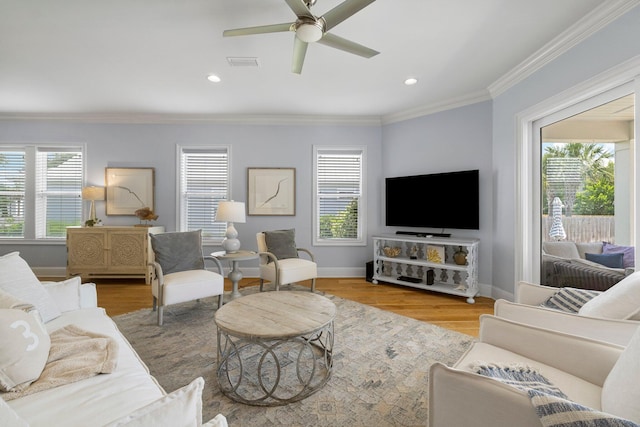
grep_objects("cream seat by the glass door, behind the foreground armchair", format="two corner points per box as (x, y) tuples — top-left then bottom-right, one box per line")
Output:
(494, 280), (640, 346)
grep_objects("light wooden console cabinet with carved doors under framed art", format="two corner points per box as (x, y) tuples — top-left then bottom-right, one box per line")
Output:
(67, 226), (164, 284)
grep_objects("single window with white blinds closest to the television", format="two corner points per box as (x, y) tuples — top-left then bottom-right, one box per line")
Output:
(314, 147), (366, 245)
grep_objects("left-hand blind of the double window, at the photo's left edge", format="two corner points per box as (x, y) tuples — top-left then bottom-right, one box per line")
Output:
(0, 150), (25, 238)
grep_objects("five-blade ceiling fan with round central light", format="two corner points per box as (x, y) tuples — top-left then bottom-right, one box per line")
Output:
(222, 0), (380, 74)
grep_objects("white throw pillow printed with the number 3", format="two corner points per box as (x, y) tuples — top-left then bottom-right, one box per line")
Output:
(0, 309), (51, 392)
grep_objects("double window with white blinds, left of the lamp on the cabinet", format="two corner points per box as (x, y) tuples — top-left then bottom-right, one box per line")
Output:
(0, 146), (83, 239)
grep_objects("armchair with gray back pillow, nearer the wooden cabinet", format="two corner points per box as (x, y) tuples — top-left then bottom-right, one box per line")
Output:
(150, 230), (224, 325)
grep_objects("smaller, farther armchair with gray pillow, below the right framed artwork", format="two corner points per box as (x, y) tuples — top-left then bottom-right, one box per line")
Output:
(256, 230), (318, 292)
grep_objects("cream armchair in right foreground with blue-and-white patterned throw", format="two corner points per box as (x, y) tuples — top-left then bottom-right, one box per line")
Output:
(428, 315), (640, 427)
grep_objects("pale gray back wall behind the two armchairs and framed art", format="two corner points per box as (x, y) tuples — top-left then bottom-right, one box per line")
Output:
(0, 121), (382, 276)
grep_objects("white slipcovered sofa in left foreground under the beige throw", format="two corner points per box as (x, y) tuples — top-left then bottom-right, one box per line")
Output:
(0, 254), (227, 427)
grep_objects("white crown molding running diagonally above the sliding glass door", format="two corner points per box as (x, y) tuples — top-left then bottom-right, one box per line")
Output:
(488, 0), (640, 98)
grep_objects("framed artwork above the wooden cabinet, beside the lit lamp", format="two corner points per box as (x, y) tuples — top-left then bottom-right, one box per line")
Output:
(105, 168), (155, 215)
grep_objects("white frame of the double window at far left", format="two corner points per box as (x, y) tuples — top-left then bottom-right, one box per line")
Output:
(0, 143), (87, 244)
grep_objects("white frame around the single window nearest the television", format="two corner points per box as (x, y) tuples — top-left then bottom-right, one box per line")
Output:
(312, 145), (367, 246)
